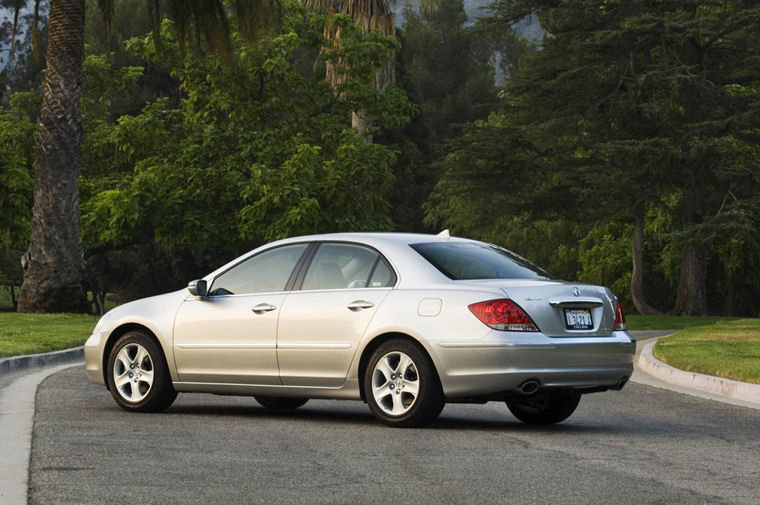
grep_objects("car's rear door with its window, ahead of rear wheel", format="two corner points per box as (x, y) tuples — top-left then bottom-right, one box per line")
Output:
(277, 242), (396, 387)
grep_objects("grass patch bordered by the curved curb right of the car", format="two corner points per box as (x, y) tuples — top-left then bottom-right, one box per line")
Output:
(654, 319), (760, 384)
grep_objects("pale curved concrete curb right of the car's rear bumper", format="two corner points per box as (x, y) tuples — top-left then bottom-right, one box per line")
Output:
(637, 339), (760, 405)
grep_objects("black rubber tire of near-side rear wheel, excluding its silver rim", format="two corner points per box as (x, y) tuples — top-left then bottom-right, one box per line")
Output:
(364, 339), (445, 427)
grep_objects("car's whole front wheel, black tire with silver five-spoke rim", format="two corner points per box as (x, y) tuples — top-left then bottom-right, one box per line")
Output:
(106, 330), (177, 412)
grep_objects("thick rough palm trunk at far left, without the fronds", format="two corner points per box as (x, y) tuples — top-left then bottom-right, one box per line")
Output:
(18, 0), (88, 312)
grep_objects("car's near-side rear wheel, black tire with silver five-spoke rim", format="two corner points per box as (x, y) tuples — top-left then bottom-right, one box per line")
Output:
(364, 339), (445, 428)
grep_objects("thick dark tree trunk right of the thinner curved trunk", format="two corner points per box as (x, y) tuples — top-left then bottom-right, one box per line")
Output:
(673, 182), (708, 316)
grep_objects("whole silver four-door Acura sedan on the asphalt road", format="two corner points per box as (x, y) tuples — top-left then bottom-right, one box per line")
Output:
(85, 232), (635, 426)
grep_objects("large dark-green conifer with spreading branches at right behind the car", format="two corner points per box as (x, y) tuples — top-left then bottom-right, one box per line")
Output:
(428, 0), (760, 314)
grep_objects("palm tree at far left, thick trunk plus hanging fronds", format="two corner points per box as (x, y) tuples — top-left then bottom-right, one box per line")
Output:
(16, 0), (279, 312)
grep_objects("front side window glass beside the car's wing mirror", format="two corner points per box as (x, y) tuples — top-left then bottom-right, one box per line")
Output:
(209, 244), (308, 296)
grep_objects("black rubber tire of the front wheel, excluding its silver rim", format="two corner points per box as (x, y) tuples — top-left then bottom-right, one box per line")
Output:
(106, 331), (177, 412)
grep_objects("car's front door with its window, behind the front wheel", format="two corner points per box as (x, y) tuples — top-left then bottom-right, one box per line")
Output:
(174, 243), (309, 385)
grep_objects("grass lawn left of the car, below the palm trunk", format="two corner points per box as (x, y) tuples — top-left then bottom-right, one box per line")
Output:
(0, 312), (98, 358)
